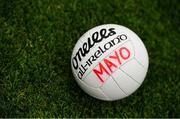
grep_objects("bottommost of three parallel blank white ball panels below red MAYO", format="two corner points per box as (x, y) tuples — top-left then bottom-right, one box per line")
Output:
(100, 77), (126, 100)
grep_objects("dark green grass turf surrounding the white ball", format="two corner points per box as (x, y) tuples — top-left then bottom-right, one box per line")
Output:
(0, 0), (180, 117)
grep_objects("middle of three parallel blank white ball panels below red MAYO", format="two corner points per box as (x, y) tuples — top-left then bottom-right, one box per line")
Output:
(112, 70), (140, 95)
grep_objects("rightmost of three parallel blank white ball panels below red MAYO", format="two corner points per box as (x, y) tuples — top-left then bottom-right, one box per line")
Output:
(120, 59), (147, 84)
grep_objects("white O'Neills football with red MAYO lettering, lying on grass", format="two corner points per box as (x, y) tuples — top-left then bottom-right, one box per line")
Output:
(71, 24), (149, 101)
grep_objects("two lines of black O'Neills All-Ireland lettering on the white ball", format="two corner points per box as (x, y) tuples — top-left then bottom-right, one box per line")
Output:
(72, 28), (127, 79)
